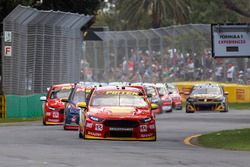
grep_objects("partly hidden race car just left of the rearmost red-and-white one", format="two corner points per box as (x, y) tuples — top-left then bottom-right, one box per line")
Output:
(155, 84), (173, 112)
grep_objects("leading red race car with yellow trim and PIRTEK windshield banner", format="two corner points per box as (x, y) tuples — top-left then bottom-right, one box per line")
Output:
(79, 86), (158, 141)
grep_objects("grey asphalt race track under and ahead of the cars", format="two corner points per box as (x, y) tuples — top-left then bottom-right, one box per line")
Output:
(0, 110), (250, 167)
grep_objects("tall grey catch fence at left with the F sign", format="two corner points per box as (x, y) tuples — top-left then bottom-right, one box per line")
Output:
(2, 6), (93, 95)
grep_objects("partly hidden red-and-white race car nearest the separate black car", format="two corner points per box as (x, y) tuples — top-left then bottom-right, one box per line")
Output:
(165, 83), (182, 110)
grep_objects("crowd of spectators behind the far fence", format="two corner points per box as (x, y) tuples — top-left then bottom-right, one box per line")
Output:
(82, 49), (250, 84)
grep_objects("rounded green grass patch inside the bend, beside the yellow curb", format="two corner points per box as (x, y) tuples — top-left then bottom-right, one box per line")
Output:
(197, 129), (250, 151)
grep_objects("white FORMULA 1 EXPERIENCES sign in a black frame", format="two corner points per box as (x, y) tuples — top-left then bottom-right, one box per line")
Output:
(211, 24), (250, 58)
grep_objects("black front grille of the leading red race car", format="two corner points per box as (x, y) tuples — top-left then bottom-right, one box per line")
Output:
(104, 120), (139, 128)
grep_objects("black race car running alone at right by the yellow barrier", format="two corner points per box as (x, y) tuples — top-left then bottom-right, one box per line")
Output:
(185, 84), (228, 113)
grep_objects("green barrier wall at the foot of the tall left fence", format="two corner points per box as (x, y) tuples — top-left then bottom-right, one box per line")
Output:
(6, 94), (43, 119)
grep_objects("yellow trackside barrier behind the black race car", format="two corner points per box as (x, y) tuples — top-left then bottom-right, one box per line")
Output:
(175, 81), (250, 103)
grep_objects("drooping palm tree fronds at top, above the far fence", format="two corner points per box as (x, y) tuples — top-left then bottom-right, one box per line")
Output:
(116, 0), (189, 28)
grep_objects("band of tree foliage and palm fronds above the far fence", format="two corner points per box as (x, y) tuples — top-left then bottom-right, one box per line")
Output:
(96, 0), (250, 30)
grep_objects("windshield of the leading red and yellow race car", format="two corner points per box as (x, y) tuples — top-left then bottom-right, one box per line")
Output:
(91, 94), (148, 107)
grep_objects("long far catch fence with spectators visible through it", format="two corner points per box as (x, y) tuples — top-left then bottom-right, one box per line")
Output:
(81, 24), (250, 84)
